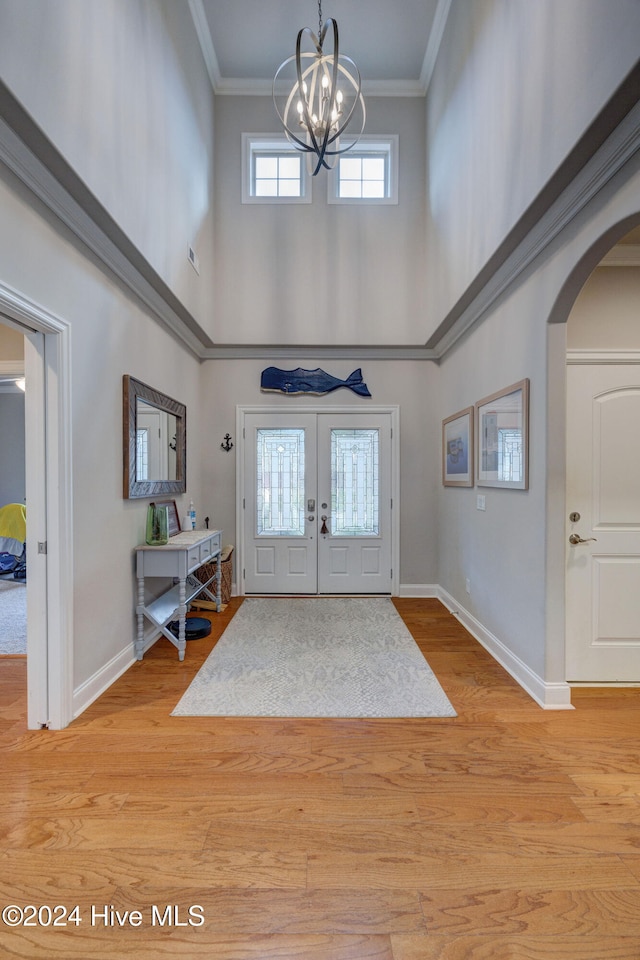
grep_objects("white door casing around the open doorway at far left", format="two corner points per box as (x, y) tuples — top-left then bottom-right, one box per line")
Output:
(0, 281), (73, 730)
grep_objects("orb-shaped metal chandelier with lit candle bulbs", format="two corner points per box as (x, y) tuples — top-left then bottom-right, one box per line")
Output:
(273, 0), (366, 177)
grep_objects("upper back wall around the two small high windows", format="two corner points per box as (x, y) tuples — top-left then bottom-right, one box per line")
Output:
(214, 96), (426, 345)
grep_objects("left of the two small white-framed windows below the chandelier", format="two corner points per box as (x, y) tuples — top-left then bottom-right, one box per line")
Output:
(242, 133), (311, 203)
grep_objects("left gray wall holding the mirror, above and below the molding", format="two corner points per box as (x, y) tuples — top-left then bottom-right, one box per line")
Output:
(0, 0), (214, 691)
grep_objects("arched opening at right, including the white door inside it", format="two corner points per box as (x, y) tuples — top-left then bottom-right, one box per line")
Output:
(563, 217), (640, 686)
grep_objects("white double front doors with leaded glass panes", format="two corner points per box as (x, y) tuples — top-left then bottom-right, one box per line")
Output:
(243, 412), (392, 594)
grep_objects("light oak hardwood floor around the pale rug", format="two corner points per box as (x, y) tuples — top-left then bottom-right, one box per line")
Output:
(0, 600), (640, 960)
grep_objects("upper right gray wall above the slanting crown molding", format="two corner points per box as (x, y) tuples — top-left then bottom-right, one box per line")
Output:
(425, 0), (640, 339)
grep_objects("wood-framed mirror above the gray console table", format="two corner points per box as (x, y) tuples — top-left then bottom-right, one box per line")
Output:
(122, 374), (187, 499)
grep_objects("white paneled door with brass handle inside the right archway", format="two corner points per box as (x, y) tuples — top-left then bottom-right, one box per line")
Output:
(566, 364), (640, 682)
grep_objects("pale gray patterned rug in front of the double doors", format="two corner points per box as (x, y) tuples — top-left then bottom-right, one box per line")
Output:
(172, 597), (456, 718)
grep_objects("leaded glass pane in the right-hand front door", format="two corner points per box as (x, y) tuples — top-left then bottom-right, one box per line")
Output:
(331, 429), (380, 537)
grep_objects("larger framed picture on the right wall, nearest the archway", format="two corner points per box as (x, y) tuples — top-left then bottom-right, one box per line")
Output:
(476, 380), (529, 490)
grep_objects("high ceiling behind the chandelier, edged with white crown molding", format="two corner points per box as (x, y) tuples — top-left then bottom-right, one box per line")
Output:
(189, 0), (451, 95)
